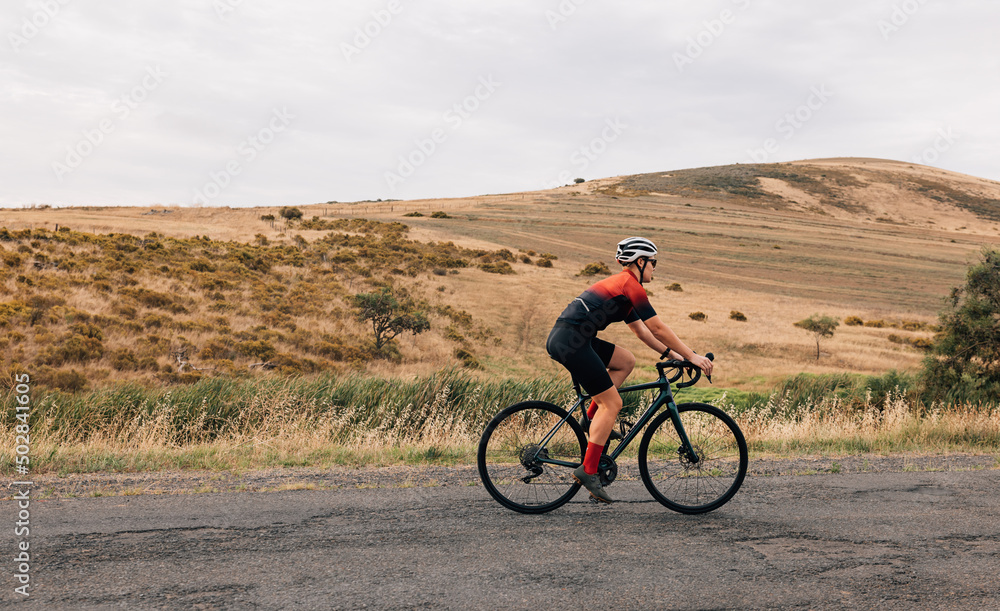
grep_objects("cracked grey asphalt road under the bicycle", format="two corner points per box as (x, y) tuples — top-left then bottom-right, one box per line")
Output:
(0, 469), (1000, 610)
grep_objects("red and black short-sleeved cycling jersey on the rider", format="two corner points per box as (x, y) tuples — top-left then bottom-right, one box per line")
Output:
(557, 270), (656, 335)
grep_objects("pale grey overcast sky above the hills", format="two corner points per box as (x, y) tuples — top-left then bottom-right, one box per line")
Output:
(0, 0), (1000, 207)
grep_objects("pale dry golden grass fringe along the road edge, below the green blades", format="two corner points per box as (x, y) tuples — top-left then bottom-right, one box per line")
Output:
(0, 386), (1000, 473)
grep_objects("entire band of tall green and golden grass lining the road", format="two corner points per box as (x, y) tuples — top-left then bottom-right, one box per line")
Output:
(0, 370), (1000, 475)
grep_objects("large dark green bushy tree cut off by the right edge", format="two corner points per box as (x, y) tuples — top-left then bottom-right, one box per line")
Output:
(923, 248), (1000, 403)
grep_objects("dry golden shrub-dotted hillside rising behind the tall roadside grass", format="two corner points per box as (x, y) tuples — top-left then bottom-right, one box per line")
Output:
(0, 155), (1000, 390)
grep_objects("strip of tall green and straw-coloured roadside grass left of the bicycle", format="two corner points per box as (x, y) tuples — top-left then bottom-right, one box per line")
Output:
(0, 370), (569, 473)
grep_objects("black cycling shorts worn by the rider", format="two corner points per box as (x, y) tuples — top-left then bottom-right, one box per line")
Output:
(545, 323), (615, 396)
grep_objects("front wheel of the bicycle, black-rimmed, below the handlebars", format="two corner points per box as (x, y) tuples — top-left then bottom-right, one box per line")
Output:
(639, 403), (748, 513)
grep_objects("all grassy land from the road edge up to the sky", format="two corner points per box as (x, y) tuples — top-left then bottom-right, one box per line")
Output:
(0, 160), (1000, 475)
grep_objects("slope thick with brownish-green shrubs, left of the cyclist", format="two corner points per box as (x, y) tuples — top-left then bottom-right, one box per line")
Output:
(0, 219), (532, 390)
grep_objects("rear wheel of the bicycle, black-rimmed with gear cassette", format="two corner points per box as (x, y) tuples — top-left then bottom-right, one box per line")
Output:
(477, 401), (587, 513)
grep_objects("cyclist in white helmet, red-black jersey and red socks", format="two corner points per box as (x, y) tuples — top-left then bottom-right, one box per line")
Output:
(545, 237), (712, 503)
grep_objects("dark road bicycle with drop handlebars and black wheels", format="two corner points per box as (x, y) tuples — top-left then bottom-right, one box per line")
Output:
(476, 354), (748, 514)
